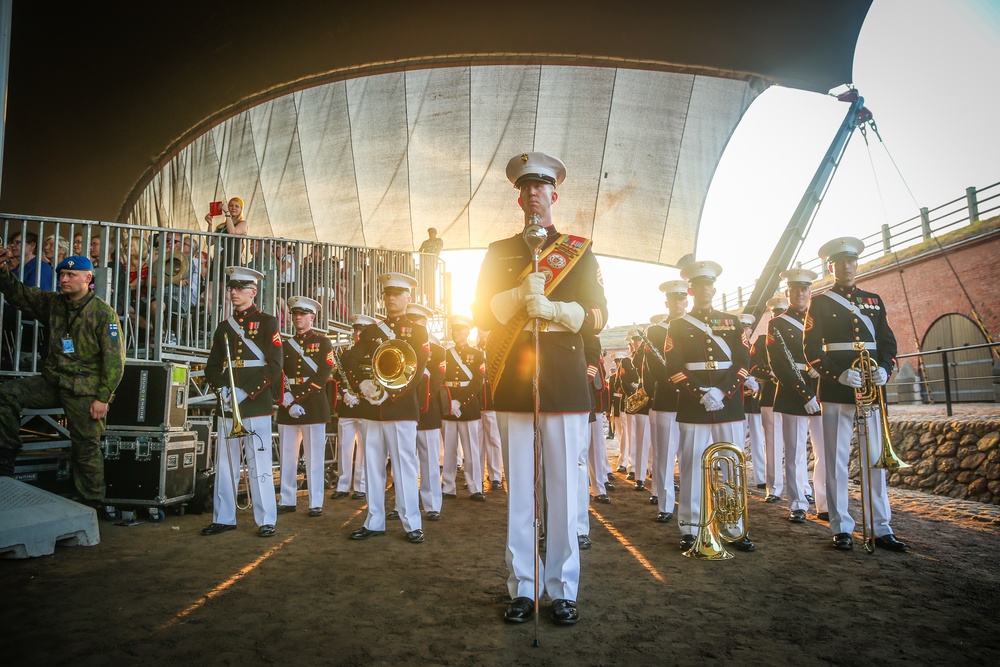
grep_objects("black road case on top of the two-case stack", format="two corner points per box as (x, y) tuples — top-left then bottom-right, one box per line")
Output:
(107, 359), (190, 431)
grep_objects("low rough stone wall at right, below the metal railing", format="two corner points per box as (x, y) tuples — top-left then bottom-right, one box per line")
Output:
(880, 419), (1000, 505)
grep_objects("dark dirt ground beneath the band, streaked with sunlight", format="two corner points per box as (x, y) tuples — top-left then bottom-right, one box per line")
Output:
(0, 434), (1000, 665)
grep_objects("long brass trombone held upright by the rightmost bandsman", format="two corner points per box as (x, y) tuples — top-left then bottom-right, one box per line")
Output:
(851, 343), (910, 553)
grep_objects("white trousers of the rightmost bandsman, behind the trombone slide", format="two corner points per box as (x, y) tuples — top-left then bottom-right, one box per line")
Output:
(823, 403), (892, 537)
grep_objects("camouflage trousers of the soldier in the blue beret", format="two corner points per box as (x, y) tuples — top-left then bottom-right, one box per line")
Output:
(0, 375), (104, 502)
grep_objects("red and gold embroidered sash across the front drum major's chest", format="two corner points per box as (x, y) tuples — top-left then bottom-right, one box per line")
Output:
(486, 234), (591, 396)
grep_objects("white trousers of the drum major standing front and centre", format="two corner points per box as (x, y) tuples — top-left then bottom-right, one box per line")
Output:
(497, 412), (587, 600)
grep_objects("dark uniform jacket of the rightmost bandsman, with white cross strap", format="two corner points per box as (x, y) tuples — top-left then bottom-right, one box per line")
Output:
(805, 285), (896, 403)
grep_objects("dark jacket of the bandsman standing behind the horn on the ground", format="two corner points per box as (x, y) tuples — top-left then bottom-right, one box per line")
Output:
(664, 309), (750, 424)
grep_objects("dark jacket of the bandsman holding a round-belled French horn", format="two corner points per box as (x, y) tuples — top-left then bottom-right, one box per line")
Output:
(341, 315), (431, 422)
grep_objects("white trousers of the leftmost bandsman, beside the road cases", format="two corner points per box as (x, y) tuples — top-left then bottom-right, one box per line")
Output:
(212, 415), (278, 526)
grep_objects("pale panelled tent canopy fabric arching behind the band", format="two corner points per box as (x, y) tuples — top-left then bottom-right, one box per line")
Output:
(129, 65), (764, 265)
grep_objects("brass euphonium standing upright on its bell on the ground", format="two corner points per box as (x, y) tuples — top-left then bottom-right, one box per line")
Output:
(684, 442), (748, 560)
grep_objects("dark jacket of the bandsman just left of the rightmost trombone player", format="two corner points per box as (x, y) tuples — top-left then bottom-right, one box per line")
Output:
(767, 309), (816, 417)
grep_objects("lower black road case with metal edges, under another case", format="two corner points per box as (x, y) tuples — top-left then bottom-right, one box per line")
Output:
(101, 429), (198, 507)
